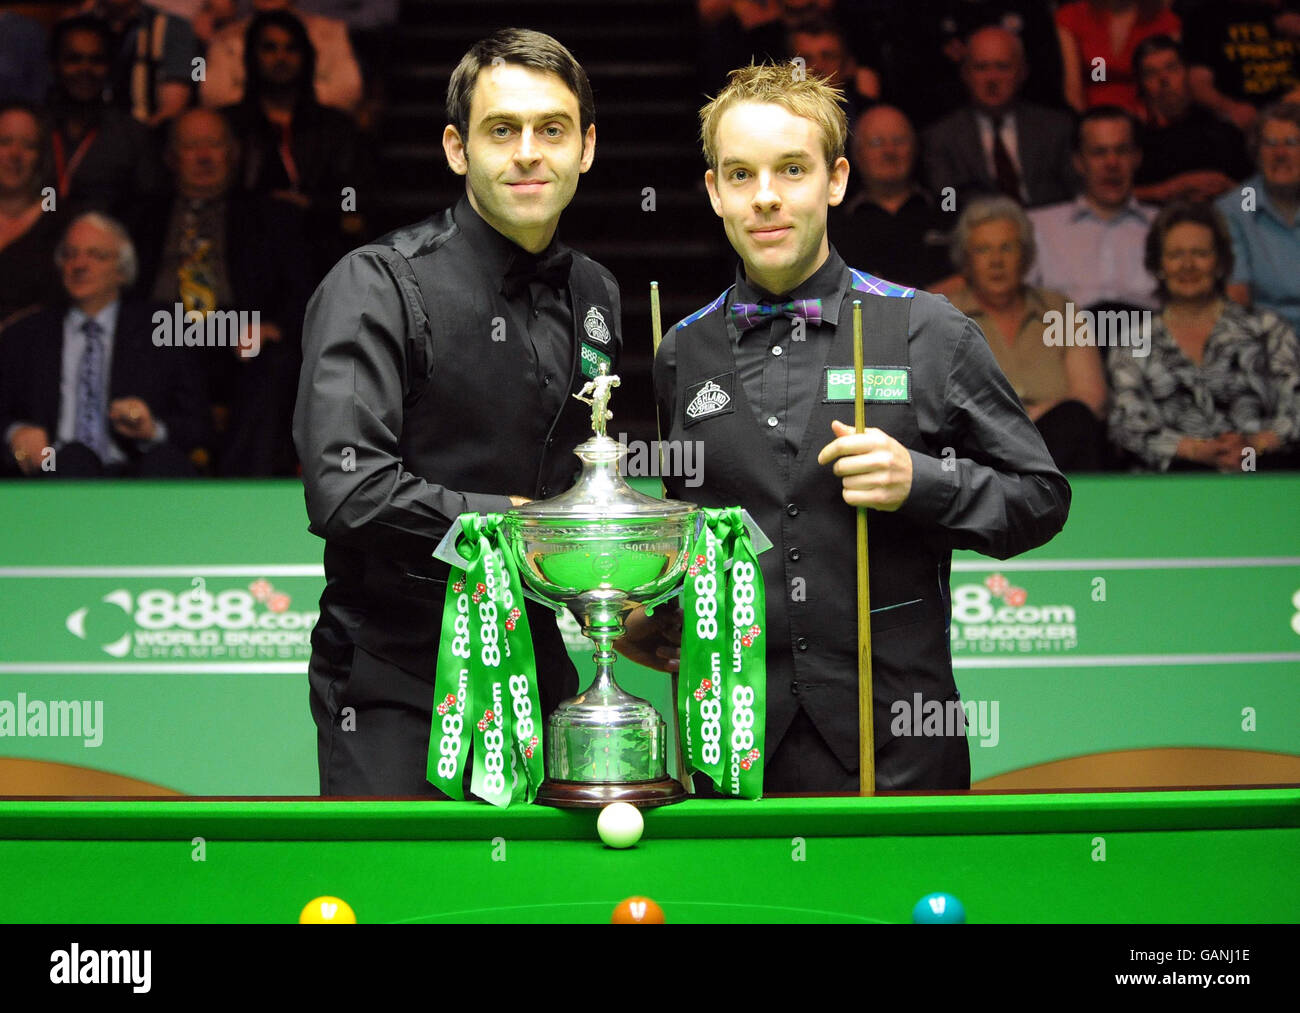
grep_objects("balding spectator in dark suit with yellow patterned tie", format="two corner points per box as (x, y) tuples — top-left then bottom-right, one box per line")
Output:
(131, 109), (312, 476)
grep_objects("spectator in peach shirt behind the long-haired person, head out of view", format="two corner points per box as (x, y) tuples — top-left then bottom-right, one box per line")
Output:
(200, 0), (363, 114)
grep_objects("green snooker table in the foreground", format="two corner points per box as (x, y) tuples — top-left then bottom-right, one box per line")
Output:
(0, 788), (1300, 925)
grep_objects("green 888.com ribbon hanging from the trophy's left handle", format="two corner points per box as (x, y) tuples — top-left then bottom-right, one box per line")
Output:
(426, 514), (545, 806)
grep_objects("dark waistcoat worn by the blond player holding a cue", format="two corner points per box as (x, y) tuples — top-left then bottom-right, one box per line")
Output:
(670, 276), (957, 770)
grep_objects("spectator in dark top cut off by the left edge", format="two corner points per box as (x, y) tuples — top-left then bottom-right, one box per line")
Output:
(0, 103), (60, 328)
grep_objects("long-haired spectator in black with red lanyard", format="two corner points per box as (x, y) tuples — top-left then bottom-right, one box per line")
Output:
(222, 10), (367, 280)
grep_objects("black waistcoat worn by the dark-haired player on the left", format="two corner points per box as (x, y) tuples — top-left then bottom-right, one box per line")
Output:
(322, 211), (621, 711)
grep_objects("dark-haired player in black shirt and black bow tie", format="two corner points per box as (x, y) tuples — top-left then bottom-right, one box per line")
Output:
(294, 29), (621, 796)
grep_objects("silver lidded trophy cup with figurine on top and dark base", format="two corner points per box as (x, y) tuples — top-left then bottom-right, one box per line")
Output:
(506, 364), (698, 809)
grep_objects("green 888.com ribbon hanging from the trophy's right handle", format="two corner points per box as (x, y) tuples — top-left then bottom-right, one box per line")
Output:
(677, 507), (767, 798)
